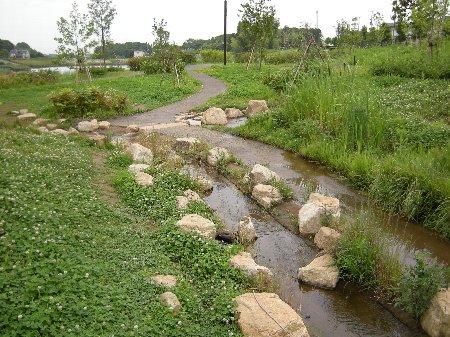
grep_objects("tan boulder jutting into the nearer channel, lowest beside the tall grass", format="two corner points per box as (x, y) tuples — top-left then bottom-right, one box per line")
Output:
(298, 254), (339, 289)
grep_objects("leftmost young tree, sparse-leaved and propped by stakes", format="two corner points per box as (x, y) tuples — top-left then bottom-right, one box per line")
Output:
(55, 2), (96, 82)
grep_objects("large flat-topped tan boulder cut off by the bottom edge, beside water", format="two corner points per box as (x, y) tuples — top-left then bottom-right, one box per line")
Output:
(234, 293), (309, 337)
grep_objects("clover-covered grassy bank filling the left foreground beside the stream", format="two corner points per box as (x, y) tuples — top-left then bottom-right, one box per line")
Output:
(0, 129), (247, 336)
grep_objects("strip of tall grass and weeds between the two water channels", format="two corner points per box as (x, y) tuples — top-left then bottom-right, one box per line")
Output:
(336, 212), (450, 319)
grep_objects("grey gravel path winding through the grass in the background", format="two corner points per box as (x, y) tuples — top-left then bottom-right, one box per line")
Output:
(109, 64), (227, 126)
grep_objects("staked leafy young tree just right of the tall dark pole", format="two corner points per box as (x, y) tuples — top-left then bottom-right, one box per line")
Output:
(240, 0), (279, 69)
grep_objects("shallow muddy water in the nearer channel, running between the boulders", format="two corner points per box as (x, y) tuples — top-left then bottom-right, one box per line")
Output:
(191, 168), (421, 337)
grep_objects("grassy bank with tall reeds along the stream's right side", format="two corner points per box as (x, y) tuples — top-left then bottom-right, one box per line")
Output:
(200, 47), (450, 238)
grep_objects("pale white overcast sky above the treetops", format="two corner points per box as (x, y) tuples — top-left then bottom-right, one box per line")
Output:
(0, 0), (392, 54)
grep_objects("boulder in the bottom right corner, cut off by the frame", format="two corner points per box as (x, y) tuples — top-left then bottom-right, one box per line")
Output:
(420, 288), (450, 337)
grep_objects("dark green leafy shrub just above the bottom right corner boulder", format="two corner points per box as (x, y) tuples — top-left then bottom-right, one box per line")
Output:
(395, 253), (450, 319)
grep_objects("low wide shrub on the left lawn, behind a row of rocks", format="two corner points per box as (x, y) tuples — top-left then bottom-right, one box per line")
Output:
(48, 87), (127, 117)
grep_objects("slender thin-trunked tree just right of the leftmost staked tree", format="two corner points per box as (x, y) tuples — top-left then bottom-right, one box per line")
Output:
(88, 0), (117, 67)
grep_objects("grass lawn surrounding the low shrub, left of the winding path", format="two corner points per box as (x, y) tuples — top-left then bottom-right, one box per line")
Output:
(0, 71), (200, 118)
